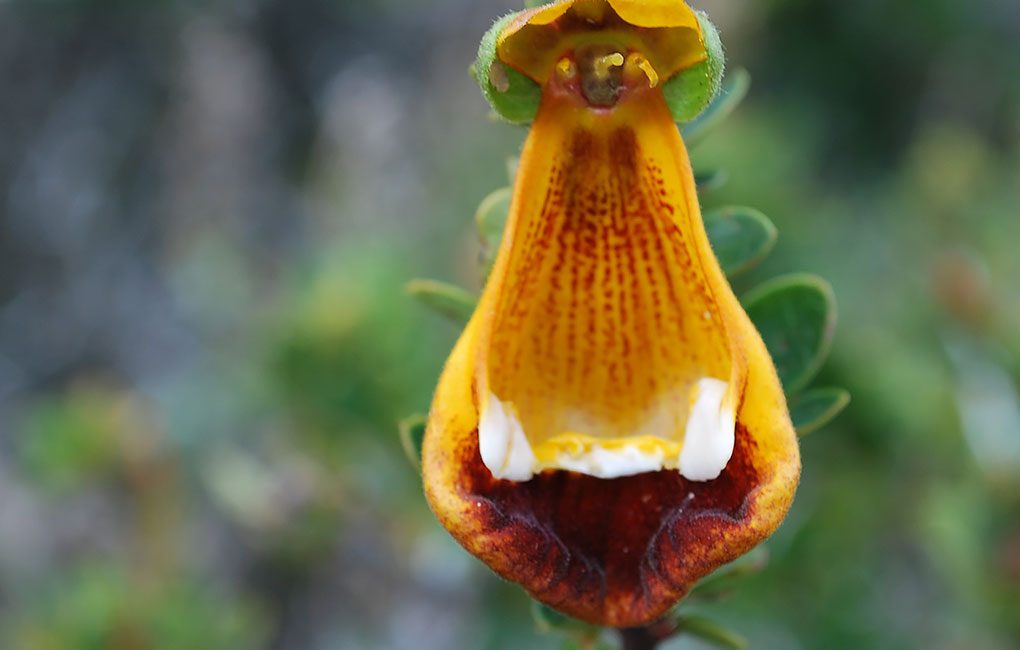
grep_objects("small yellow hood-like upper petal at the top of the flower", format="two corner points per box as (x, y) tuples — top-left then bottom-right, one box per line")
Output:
(497, 0), (708, 86)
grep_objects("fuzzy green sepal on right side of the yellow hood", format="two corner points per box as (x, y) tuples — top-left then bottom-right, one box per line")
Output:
(662, 11), (726, 122)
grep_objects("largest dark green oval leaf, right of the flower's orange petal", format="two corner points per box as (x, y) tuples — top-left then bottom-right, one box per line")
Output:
(743, 273), (835, 396)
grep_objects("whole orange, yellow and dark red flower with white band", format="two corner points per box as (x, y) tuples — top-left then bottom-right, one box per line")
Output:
(422, 0), (800, 627)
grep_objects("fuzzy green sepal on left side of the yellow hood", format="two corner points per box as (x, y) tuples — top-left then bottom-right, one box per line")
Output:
(471, 13), (542, 124)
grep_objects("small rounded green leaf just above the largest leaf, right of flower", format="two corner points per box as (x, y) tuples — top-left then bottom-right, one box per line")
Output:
(705, 207), (776, 277)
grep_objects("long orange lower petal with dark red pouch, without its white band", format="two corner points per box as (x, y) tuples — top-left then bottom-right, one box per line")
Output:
(422, 61), (800, 627)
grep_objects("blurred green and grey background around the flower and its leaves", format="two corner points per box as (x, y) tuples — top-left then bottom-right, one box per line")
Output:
(0, 0), (1020, 650)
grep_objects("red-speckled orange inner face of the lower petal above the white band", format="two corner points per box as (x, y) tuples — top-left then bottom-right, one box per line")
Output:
(486, 125), (744, 447)
